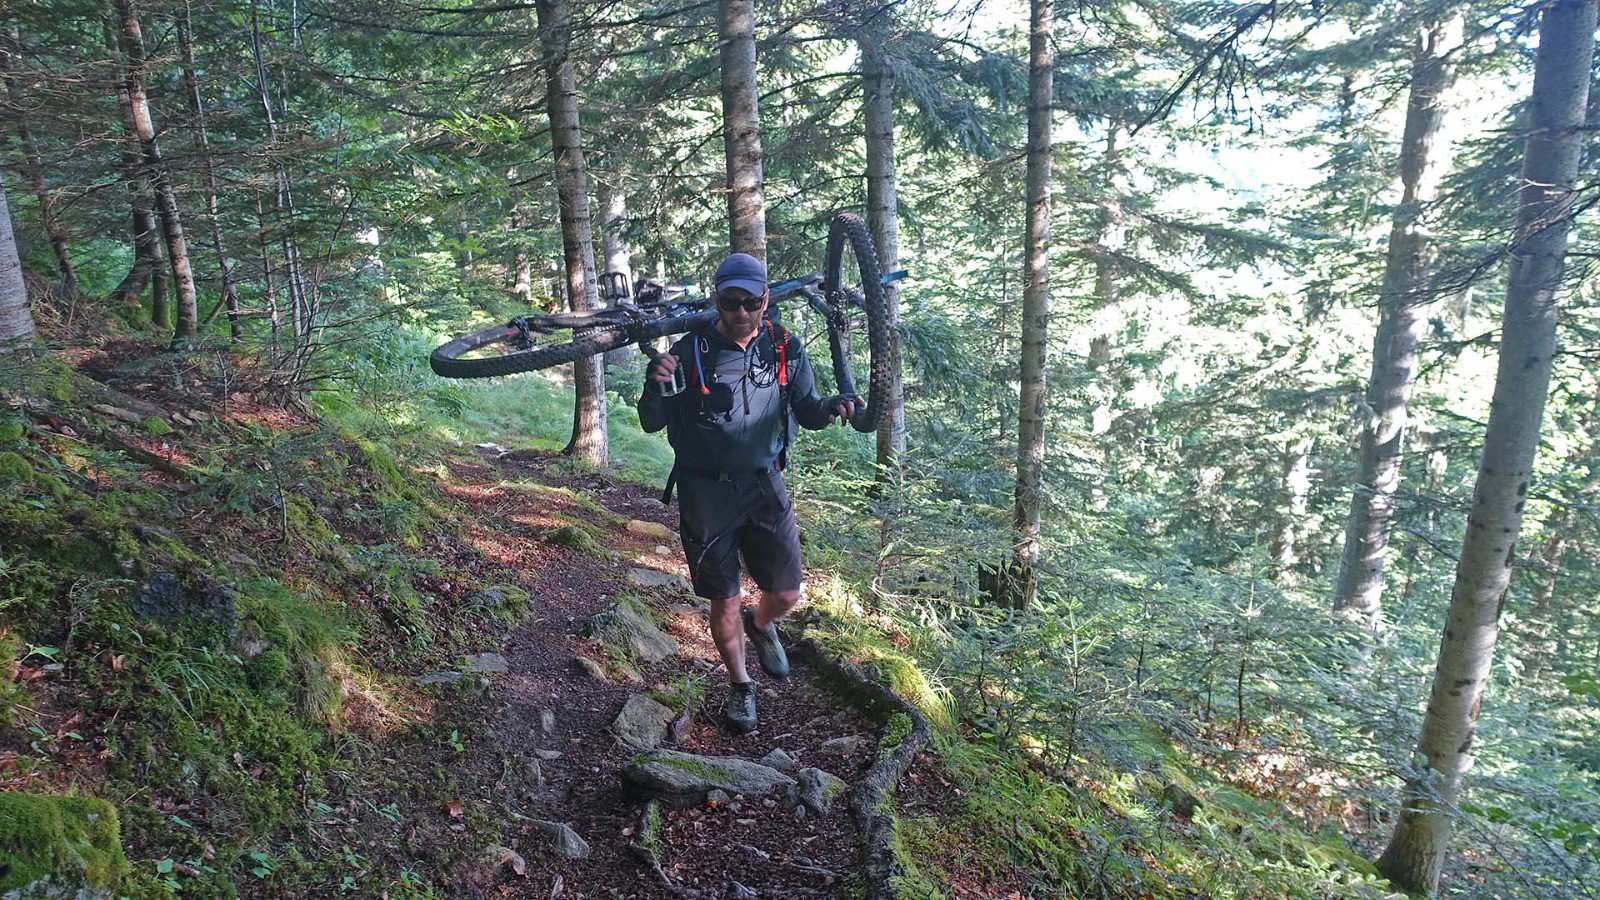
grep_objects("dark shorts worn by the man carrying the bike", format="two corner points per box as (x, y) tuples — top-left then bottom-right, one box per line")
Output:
(678, 471), (800, 601)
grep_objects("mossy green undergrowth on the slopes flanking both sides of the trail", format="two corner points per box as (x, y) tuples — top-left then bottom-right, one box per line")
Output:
(0, 318), (1446, 897)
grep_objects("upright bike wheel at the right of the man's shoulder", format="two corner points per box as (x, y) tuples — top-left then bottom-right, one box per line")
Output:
(822, 213), (891, 432)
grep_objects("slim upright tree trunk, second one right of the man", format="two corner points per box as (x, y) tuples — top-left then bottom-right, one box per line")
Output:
(1014, 0), (1054, 609)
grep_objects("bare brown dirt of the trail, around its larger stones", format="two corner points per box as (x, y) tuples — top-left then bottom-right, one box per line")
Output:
(438, 456), (875, 898)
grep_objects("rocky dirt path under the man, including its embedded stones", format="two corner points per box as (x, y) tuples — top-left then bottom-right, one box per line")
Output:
(438, 448), (875, 898)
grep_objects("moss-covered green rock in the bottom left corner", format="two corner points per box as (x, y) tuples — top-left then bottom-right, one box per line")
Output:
(0, 793), (128, 900)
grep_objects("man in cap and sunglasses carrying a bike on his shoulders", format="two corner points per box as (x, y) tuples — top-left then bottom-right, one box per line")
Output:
(638, 253), (861, 733)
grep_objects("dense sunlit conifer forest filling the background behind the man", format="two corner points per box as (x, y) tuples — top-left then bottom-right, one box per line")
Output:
(0, 0), (1600, 897)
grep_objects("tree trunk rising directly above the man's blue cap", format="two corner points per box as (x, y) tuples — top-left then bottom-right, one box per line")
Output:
(718, 0), (766, 259)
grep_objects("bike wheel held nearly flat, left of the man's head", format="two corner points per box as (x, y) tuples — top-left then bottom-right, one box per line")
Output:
(427, 307), (717, 378)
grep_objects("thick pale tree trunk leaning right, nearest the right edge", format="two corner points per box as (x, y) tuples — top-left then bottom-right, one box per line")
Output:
(1378, 0), (1600, 892)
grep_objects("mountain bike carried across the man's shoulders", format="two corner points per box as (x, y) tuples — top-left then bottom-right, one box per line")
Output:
(427, 213), (906, 432)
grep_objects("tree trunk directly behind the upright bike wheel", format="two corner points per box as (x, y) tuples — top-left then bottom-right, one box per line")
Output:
(861, 29), (906, 482)
